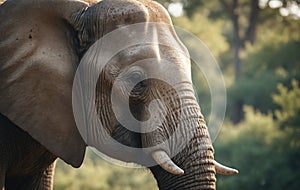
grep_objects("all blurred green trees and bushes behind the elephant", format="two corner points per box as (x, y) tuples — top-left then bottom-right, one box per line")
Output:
(55, 0), (300, 190)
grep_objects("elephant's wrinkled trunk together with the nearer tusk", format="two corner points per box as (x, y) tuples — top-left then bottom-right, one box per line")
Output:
(142, 84), (216, 190)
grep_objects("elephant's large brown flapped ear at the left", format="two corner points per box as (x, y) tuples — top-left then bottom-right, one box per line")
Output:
(0, 0), (87, 167)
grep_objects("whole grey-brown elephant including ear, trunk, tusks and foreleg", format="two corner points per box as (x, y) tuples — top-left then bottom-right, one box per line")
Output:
(0, 0), (238, 190)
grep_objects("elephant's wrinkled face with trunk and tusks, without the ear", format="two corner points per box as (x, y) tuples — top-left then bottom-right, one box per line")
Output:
(72, 1), (236, 189)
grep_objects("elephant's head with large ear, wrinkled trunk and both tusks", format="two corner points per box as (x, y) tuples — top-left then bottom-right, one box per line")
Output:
(0, 0), (237, 189)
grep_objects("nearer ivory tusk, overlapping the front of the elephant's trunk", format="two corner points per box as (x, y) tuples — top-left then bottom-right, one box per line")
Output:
(152, 150), (184, 175)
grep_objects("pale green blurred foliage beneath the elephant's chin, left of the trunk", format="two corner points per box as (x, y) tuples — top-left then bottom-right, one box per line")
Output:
(54, 151), (157, 190)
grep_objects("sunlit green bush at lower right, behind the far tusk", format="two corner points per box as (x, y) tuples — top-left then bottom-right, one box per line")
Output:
(215, 81), (300, 190)
